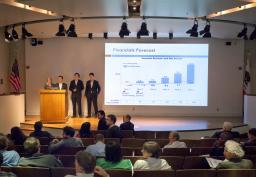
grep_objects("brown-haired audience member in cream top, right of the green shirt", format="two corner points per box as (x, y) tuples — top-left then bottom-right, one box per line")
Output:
(133, 141), (171, 170)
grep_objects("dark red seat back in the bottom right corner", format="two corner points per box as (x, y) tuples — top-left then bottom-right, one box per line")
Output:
(216, 169), (256, 177)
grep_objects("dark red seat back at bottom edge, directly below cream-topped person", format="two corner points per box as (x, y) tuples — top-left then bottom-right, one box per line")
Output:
(133, 170), (175, 177)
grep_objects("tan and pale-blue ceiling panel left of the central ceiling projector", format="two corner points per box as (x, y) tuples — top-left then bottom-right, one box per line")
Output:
(17, 0), (128, 17)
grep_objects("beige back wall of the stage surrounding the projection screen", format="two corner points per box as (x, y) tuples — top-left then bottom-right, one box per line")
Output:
(25, 38), (244, 116)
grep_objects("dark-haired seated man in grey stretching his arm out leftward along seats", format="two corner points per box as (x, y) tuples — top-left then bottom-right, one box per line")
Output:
(49, 126), (84, 153)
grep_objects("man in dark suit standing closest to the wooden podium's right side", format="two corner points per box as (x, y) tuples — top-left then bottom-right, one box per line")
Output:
(69, 73), (84, 117)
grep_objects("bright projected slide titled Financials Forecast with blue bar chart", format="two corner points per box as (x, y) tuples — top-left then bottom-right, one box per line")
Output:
(104, 43), (209, 106)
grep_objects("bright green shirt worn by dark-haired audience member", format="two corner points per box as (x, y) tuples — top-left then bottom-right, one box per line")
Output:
(96, 158), (132, 170)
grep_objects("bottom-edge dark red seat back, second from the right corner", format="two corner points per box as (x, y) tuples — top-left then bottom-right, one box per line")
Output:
(176, 169), (216, 177)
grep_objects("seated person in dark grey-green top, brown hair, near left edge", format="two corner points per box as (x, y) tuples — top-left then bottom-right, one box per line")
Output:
(18, 137), (63, 167)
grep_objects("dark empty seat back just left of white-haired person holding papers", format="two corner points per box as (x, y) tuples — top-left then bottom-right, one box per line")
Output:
(183, 156), (210, 169)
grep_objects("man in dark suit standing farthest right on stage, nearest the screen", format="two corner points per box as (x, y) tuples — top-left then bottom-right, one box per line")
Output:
(85, 73), (100, 117)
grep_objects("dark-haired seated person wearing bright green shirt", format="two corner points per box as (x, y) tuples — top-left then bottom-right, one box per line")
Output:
(96, 142), (132, 170)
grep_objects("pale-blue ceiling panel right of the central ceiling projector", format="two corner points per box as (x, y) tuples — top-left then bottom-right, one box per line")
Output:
(141, 0), (247, 17)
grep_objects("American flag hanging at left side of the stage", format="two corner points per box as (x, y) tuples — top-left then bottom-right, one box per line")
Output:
(10, 59), (21, 92)
